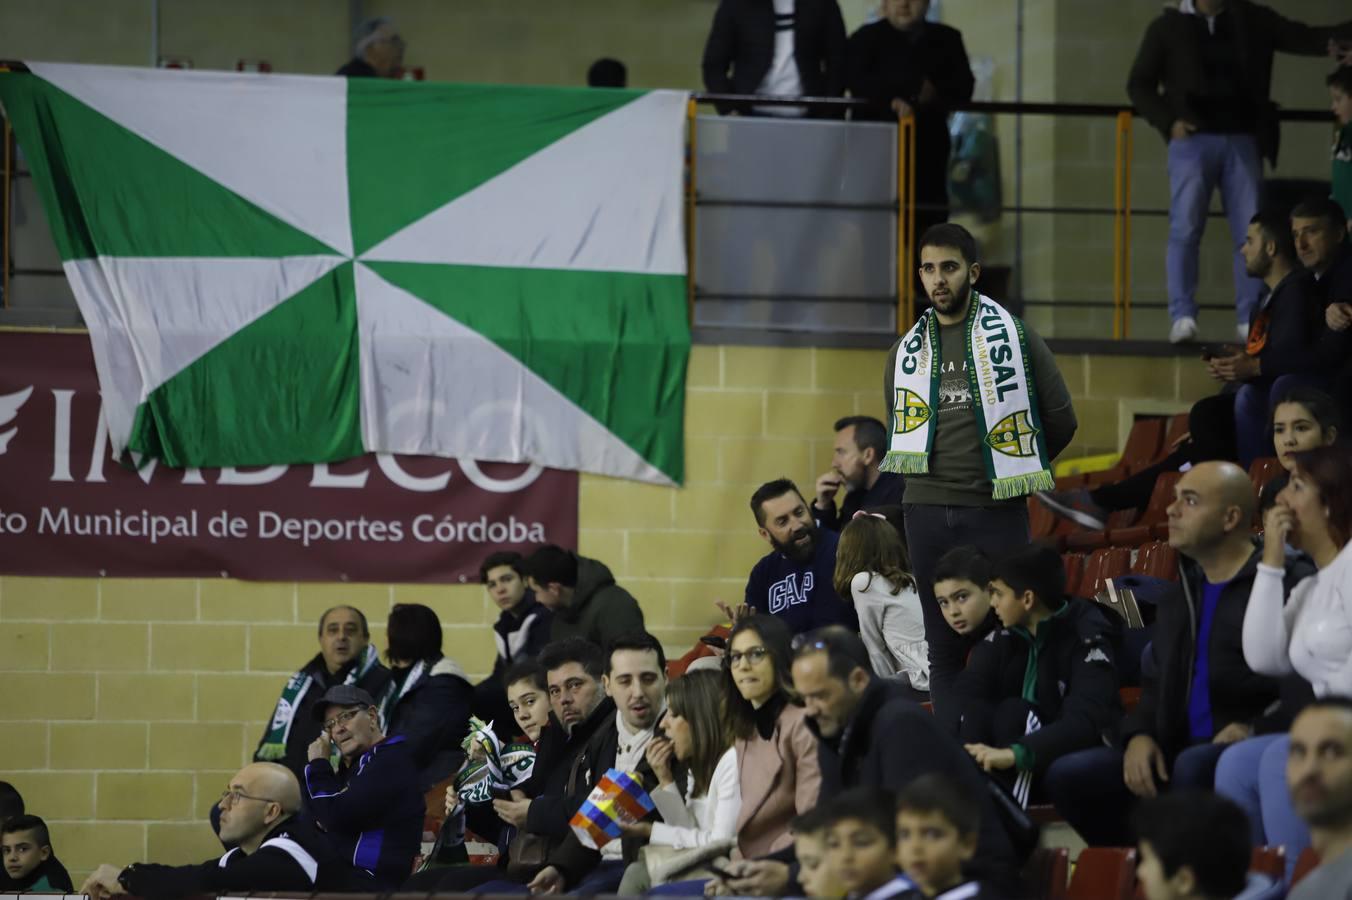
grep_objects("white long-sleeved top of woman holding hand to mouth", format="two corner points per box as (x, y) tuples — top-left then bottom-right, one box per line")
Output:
(1244, 542), (1352, 697)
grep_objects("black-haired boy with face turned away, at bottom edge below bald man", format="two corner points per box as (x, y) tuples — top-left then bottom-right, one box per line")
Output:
(1136, 791), (1251, 900)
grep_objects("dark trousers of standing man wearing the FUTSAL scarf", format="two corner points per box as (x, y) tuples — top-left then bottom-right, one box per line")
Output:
(903, 500), (1029, 734)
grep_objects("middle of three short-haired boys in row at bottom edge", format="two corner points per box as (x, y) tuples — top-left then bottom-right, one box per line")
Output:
(825, 788), (915, 900)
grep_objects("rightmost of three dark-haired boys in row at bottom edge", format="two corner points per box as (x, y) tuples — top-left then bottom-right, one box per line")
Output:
(896, 774), (990, 900)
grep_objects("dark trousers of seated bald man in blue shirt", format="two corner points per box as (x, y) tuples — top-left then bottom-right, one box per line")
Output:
(1042, 743), (1229, 847)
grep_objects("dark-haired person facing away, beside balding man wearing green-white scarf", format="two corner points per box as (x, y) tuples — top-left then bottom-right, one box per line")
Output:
(379, 603), (475, 789)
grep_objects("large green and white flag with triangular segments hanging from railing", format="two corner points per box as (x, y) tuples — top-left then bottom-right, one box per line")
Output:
(0, 64), (690, 484)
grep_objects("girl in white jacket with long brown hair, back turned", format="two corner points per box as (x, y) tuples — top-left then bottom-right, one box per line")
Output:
(836, 514), (929, 691)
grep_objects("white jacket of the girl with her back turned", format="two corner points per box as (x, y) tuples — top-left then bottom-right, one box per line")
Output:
(849, 572), (929, 691)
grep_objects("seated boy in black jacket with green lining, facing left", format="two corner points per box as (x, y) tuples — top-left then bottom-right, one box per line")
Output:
(956, 546), (1119, 805)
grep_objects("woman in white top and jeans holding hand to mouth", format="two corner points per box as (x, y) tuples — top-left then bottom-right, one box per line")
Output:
(1215, 447), (1352, 870)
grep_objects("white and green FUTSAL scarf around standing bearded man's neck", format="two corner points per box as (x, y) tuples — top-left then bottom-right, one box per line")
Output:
(882, 291), (1056, 500)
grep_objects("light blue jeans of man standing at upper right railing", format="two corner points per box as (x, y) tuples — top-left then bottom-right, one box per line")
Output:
(1164, 134), (1263, 324)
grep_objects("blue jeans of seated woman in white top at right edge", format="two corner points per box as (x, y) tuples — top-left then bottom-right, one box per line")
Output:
(1215, 734), (1310, 878)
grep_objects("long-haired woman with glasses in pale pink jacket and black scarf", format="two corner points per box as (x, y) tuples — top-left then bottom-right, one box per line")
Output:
(723, 616), (822, 859)
